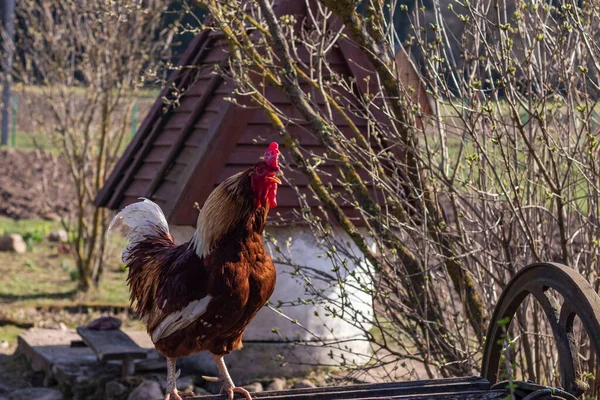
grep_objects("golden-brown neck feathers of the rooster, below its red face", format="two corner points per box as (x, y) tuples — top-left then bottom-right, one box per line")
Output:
(191, 170), (268, 257)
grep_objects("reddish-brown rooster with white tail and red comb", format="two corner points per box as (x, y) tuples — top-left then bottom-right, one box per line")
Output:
(109, 143), (281, 400)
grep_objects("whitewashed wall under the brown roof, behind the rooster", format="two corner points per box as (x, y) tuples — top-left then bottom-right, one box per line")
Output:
(171, 226), (373, 378)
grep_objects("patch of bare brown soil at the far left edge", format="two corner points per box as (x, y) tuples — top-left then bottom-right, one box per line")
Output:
(0, 149), (74, 220)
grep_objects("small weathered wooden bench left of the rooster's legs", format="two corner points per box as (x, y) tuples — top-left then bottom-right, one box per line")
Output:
(77, 327), (148, 377)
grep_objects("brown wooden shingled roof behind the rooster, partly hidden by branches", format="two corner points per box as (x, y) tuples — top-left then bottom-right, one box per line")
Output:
(95, 0), (430, 226)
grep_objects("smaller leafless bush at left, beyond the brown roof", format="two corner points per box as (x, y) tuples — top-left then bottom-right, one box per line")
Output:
(9, 0), (173, 291)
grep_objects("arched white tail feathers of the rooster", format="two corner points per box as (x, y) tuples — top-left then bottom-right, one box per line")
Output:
(107, 199), (169, 264)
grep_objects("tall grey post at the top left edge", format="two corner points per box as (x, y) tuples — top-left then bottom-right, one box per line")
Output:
(1, 0), (15, 145)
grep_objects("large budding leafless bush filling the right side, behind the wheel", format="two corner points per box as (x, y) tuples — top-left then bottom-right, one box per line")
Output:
(195, 0), (600, 392)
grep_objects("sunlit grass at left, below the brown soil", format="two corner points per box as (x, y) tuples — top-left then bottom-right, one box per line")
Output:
(0, 223), (134, 353)
